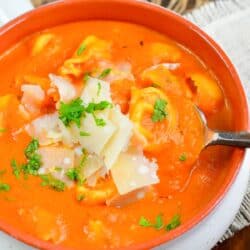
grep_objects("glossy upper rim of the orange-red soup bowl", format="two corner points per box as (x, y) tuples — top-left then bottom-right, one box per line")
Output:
(0, 0), (250, 250)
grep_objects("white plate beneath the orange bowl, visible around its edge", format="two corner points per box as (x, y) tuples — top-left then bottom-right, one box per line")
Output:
(0, 0), (250, 250)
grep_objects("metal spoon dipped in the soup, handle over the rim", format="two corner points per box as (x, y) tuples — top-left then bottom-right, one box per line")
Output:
(196, 107), (250, 148)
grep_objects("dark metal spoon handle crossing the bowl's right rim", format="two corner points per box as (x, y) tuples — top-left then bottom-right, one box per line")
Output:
(207, 131), (250, 148)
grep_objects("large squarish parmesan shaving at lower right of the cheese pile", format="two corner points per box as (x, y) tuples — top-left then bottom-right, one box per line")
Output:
(111, 153), (159, 195)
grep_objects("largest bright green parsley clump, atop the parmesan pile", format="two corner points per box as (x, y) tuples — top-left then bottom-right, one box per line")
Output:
(59, 98), (84, 127)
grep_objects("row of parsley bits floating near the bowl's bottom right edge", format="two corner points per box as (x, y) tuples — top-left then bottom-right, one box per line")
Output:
(139, 214), (181, 231)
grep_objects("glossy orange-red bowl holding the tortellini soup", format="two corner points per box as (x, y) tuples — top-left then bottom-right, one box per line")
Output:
(0, 0), (248, 250)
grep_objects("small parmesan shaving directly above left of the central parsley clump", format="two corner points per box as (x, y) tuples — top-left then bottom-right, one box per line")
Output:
(49, 74), (77, 102)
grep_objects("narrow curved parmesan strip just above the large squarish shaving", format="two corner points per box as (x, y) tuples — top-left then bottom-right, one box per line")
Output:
(102, 106), (133, 169)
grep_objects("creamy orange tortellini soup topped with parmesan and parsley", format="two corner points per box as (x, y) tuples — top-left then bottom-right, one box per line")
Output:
(0, 21), (232, 249)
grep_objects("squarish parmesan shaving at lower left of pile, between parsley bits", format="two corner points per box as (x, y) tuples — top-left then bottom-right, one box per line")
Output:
(38, 146), (75, 186)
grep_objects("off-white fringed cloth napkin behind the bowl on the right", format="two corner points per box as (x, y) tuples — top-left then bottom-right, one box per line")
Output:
(186, 0), (250, 241)
